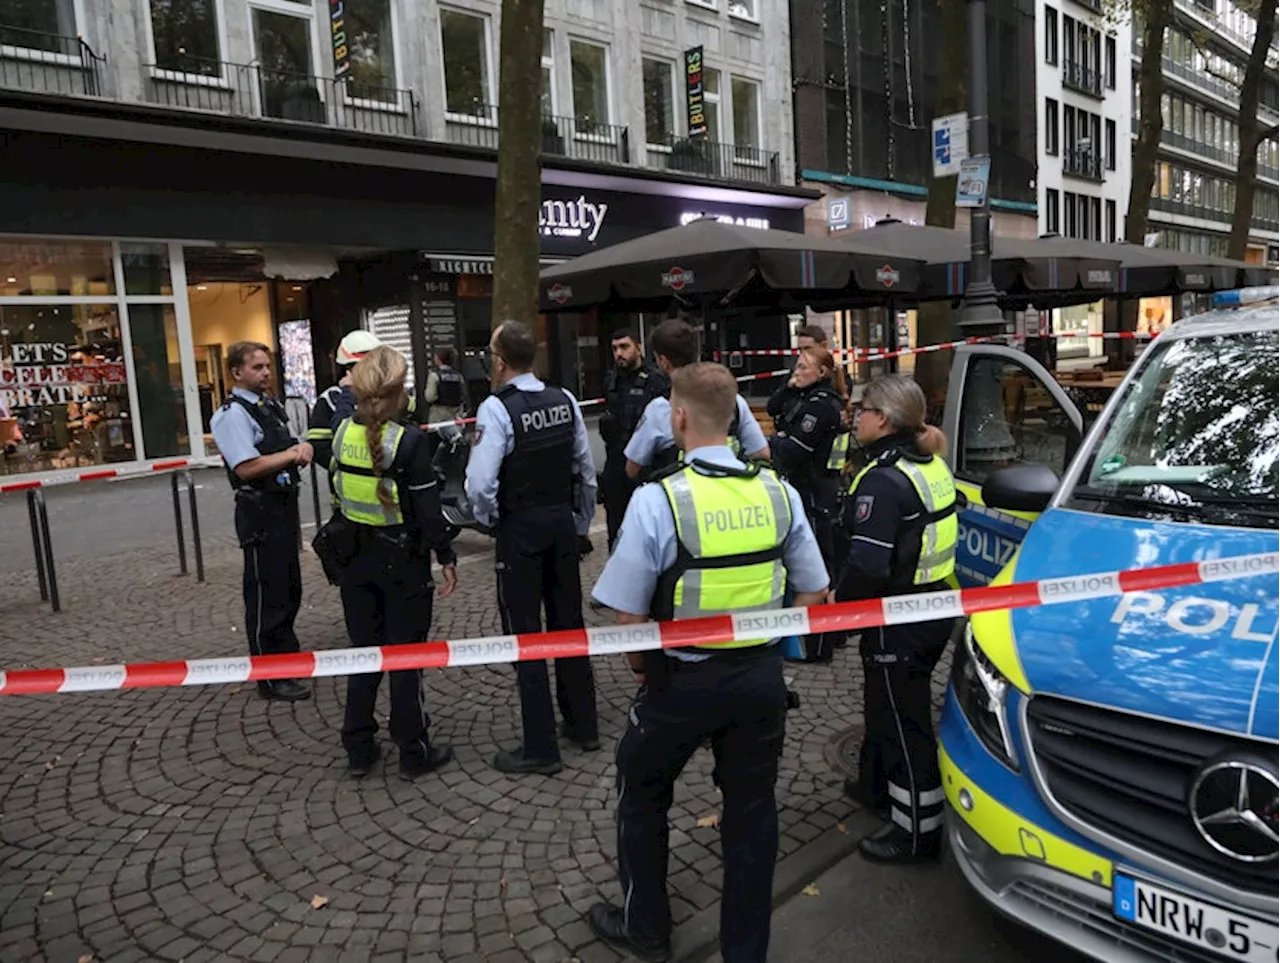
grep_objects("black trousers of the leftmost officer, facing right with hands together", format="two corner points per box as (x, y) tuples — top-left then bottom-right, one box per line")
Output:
(236, 492), (302, 656)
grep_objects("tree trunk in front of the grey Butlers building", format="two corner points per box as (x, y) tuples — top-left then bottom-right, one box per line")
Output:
(493, 0), (543, 328)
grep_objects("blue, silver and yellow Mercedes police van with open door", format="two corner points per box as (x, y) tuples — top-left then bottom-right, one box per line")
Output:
(940, 300), (1280, 963)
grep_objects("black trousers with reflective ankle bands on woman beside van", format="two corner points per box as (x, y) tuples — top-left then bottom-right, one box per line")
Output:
(858, 612), (955, 848)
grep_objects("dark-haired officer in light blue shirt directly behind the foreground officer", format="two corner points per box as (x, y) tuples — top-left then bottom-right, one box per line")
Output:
(623, 318), (769, 479)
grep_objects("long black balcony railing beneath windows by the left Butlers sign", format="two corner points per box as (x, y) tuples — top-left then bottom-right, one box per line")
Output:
(143, 56), (417, 137)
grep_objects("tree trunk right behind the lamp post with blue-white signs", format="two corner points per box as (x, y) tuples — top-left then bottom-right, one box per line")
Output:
(915, 0), (969, 417)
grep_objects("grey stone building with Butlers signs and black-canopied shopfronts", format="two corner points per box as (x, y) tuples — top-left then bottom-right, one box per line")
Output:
(0, 0), (815, 473)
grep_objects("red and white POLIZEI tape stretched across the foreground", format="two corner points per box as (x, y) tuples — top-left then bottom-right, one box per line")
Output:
(0, 552), (1280, 695)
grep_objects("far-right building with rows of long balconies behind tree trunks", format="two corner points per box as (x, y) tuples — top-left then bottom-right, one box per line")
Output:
(1133, 0), (1280, 264)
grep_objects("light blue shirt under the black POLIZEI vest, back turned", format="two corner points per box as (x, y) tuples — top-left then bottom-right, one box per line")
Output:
(467, 371), (595, 535)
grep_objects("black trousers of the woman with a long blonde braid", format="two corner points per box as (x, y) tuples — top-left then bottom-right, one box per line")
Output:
(339, 535), (433, 759)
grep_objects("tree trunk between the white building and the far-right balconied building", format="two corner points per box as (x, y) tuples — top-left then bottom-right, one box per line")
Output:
(1105, 0), (1174, 370)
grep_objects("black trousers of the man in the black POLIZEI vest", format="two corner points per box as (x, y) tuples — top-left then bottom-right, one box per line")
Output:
(495, 506), (599, 761)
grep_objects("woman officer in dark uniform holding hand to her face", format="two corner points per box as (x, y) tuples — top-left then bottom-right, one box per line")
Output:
(768, 346), (849, 662)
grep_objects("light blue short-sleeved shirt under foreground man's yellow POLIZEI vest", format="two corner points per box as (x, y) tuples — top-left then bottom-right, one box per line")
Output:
(591, 446), (829, 640)
